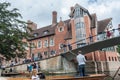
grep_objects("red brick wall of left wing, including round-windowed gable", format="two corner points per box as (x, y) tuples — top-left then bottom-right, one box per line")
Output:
(27, 22), (67, 58)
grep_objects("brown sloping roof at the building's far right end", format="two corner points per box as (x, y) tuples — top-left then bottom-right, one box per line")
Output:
(97, 18), (112, 33)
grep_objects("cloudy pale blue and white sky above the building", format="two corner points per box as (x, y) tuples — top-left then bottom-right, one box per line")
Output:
(0, 0), (120, 28)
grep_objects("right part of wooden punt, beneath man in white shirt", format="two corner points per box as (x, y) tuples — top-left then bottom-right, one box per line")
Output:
(46, 74), (106, 80)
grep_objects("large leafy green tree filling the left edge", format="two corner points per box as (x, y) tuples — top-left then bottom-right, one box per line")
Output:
(0, 2), (28, 59)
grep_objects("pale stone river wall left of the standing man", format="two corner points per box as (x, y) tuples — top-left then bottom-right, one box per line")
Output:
(3, 56), (76, 73)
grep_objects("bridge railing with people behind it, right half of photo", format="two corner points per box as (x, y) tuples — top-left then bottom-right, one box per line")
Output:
(60, 28), (120, 52)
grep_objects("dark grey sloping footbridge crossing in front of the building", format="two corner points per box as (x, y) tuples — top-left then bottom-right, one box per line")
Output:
(61, 28), (120, 60)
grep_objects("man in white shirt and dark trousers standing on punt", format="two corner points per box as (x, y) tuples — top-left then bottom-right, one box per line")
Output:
(76, 51), (86, 76)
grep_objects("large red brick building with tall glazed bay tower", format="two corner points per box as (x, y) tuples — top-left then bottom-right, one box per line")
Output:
(27, 4), (118, 61)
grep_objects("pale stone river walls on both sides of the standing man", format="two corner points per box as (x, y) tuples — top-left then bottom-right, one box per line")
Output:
(2, 56), (120, 73)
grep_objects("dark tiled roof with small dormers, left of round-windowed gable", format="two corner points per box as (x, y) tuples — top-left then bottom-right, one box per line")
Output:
(29, 19), (70, 40)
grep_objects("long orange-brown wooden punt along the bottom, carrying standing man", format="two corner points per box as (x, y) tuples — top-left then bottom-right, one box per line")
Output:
(8, 74), (107, 80)
